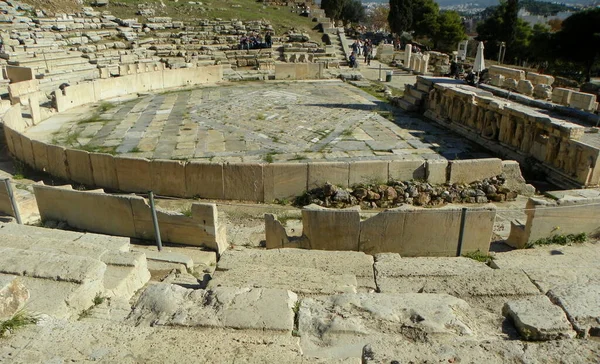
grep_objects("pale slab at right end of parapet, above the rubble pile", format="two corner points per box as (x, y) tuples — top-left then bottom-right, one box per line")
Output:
(449, 158), (502, 183)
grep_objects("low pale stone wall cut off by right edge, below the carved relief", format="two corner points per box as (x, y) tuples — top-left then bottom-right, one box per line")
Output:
(506, 189), (600, 248)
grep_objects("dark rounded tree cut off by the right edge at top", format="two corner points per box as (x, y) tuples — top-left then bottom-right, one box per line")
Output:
(556, 8), (600, 82)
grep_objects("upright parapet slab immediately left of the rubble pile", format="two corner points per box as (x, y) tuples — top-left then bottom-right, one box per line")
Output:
(263, 163), (308, 202)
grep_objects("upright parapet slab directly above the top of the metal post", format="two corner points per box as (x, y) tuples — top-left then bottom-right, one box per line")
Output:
(150, 159), (186, 197)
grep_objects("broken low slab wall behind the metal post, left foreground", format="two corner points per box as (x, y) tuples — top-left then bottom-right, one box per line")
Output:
(34, 185), (228, 254)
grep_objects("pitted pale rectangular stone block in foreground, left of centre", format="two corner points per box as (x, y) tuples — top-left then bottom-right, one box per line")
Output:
(129, 283), (297, 333)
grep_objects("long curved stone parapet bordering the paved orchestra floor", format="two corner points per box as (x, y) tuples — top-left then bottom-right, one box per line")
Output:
(3, 65), (520, 202)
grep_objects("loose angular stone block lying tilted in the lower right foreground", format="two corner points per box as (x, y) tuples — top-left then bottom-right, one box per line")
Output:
(502, 295), (575, 341)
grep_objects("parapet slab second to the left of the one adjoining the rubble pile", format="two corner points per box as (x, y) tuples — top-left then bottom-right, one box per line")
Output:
(185, 161), (224, 200)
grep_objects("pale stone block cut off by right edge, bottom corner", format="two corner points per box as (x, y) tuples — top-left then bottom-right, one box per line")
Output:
(548, 285), (600, 337)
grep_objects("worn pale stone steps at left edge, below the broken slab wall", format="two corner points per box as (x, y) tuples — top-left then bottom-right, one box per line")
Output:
(0, 223), (150, 319)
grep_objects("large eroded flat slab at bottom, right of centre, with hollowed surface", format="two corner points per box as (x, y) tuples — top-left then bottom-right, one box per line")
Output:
(298, 293), (475, 357)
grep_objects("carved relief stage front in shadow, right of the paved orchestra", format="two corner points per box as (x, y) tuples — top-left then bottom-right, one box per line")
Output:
(417, 77), (600, 188)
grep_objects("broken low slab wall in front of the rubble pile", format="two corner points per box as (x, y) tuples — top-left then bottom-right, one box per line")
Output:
(265, 204), (496, 257)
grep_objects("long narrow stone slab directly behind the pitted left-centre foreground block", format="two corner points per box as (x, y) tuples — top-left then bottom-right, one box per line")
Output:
(208, 264), (358, 295)
